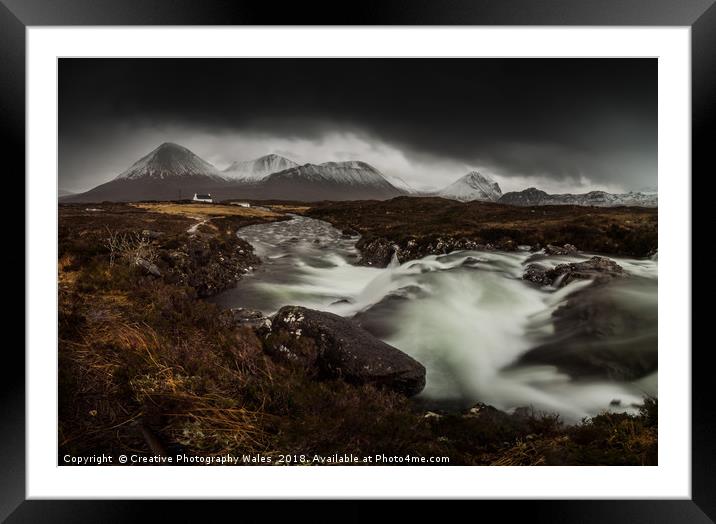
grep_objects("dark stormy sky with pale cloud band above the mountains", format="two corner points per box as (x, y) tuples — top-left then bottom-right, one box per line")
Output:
(59, 58), (657, 192)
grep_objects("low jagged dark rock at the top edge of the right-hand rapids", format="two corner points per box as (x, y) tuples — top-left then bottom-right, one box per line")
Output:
(522, 256), (626, 287)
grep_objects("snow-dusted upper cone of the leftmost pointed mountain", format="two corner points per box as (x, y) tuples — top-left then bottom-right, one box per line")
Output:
(115, 142), (224, 180)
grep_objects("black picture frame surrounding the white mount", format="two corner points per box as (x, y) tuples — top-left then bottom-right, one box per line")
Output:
(7, 0), (716, 523)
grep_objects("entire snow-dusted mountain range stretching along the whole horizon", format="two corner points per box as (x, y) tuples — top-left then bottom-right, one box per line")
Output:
(60, 142), (656, 206)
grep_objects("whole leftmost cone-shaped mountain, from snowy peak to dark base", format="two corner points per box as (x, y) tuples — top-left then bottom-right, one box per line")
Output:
(60, 142), (229, 202)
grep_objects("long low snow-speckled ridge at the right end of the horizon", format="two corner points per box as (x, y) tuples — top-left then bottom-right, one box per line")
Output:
(499, 187), (658, 207)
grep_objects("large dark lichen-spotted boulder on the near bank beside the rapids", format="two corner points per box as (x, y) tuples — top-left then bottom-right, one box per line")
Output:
(266, 306), (425, 396)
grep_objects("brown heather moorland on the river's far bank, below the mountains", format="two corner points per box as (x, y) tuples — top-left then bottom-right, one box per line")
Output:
(304, 197), (658, 267)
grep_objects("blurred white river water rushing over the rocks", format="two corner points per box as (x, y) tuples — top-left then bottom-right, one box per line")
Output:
(215, 217), (657, 420)
